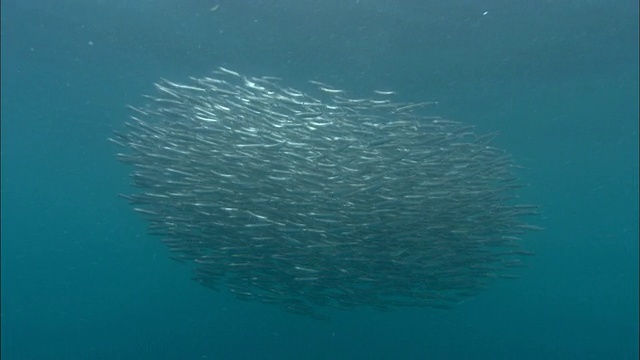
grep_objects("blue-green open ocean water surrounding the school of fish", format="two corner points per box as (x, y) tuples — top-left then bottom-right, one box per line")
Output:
(1, 0), (639, 359)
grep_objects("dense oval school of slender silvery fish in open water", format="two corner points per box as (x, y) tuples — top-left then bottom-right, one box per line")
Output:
(110, 68), (537, 316)
